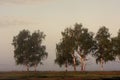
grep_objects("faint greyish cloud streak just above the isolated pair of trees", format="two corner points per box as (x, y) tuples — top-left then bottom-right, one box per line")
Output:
(0, 16), (38, 27)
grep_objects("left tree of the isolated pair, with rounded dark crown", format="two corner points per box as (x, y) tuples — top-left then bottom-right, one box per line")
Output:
(12, 30), (30, 71)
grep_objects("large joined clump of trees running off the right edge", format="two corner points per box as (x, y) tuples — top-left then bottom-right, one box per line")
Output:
(55, 23), (120, 71)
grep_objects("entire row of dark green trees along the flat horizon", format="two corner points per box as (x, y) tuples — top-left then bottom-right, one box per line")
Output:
(12, 23), (120, 71)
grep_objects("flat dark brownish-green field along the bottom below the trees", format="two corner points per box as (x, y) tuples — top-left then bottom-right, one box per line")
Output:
(0, 71), (120, 80)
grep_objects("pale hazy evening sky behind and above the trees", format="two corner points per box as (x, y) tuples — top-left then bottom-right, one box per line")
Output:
(0, 0), (120, 71)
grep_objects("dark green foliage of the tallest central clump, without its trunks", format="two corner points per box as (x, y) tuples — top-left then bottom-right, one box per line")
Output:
(55, 24), (95, 66)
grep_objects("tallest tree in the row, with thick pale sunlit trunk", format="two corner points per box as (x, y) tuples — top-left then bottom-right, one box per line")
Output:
(74, 23), (95, 71)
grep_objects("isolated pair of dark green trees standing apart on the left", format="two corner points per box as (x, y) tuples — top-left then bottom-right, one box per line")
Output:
(12, 30), (47, 71)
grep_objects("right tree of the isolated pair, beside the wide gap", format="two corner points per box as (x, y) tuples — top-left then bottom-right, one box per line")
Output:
(30, 30), (48, 71)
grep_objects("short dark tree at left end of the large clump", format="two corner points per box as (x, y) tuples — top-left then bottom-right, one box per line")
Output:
(55, 41), (72, 71)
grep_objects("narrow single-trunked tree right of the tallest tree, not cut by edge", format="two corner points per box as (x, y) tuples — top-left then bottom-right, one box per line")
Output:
(94, 26), (114, 70)
